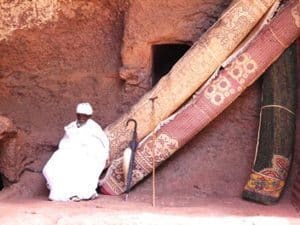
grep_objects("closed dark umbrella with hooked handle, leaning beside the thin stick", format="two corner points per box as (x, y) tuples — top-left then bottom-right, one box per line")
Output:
(123, 119), (138, 201)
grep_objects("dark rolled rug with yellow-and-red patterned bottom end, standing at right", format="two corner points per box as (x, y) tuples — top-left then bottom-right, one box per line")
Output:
(242, 45), (297, 204)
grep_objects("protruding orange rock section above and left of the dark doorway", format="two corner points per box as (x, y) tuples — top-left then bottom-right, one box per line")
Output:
(120, 0), (232, 103)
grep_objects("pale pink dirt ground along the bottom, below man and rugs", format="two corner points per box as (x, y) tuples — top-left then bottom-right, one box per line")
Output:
(0, 192), (300, 225)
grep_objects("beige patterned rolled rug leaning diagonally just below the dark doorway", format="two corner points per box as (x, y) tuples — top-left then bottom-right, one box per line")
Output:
(105, 0), (275, 161)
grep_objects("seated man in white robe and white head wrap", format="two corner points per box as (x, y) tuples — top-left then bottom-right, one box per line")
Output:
(43, 103), (109, 201)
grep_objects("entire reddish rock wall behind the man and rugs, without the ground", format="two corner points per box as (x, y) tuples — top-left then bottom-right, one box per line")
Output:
(0, 0), (298, 200)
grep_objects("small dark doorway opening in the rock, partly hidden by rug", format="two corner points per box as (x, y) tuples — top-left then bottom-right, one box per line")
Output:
(152, 44), (190, 86)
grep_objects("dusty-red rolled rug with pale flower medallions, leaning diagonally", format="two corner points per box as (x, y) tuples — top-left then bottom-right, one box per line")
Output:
(101, 0), (300, 195)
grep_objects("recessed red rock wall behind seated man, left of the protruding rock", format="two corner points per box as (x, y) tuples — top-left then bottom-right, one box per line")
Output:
(0, 0), (127, 188)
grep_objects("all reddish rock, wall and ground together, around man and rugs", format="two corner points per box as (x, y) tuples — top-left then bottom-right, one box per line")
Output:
(0, 0), (300, 225)
